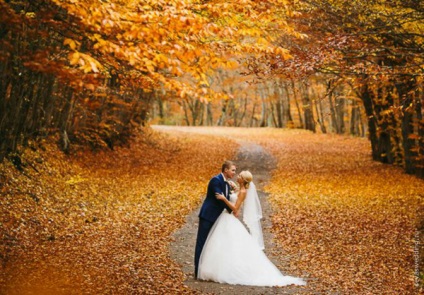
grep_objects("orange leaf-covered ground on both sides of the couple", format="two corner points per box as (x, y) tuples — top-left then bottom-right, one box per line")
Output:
(0, 127), (424, 295)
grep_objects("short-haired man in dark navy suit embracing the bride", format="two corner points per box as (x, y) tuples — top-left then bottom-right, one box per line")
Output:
(194, 161), (236, 279)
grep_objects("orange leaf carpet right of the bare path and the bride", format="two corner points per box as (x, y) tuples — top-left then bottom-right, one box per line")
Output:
(158, 128), (424, 294)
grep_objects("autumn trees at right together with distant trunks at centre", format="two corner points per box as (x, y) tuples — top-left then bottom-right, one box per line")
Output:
(154, 0), (424, 177)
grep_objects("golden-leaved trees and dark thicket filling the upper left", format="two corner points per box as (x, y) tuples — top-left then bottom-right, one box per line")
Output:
(0, 0), (294, 159)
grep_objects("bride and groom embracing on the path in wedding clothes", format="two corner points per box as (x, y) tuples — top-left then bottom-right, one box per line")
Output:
(194, 161), (305, 286)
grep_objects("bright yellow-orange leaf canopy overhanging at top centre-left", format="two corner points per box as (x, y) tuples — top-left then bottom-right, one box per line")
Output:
(56, 0), (296, 96)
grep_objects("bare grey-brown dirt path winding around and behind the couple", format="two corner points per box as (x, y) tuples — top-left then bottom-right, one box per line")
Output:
(170, 142), (299, 294)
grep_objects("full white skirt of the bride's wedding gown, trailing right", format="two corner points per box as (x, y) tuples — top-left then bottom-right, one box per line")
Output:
(198, 211), (306, 286)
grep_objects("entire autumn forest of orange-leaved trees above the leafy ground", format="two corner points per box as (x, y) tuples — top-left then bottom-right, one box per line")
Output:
(0, 0), (424, 177)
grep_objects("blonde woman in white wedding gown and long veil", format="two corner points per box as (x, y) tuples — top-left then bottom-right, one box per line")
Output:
(198, 171), (306, 286)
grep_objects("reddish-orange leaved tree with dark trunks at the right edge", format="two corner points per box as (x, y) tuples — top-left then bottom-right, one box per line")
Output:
(263, 0), (424, 176)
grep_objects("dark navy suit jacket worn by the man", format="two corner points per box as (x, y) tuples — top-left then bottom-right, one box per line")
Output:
(199, 173), (232, 222)
